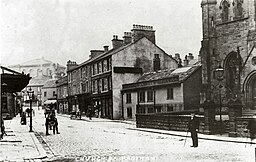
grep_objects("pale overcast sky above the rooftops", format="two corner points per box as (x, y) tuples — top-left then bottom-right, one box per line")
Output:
(0, 0), (202, 66)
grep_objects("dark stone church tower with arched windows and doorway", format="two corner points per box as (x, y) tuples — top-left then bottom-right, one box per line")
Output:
(200, 0), (256, 136)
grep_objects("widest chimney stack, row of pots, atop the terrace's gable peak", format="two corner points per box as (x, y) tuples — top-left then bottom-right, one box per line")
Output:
(132, 24), (156, 43)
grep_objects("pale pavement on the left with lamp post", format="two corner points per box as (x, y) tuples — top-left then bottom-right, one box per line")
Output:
(0, 112), (47, 162)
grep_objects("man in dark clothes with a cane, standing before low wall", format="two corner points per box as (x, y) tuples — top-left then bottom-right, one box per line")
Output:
(188, 113), (199, 147)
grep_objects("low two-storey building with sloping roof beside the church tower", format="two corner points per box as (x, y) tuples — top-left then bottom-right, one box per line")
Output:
(122, 63), (202, 119)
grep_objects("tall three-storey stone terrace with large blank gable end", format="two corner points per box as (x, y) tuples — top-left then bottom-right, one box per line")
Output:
(67, 25), (178, 119)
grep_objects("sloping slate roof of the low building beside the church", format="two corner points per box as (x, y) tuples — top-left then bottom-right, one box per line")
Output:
(137, 65), (201, 83)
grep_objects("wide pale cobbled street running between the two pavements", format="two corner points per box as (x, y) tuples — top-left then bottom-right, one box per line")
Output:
(30, 110), (255, 162)
